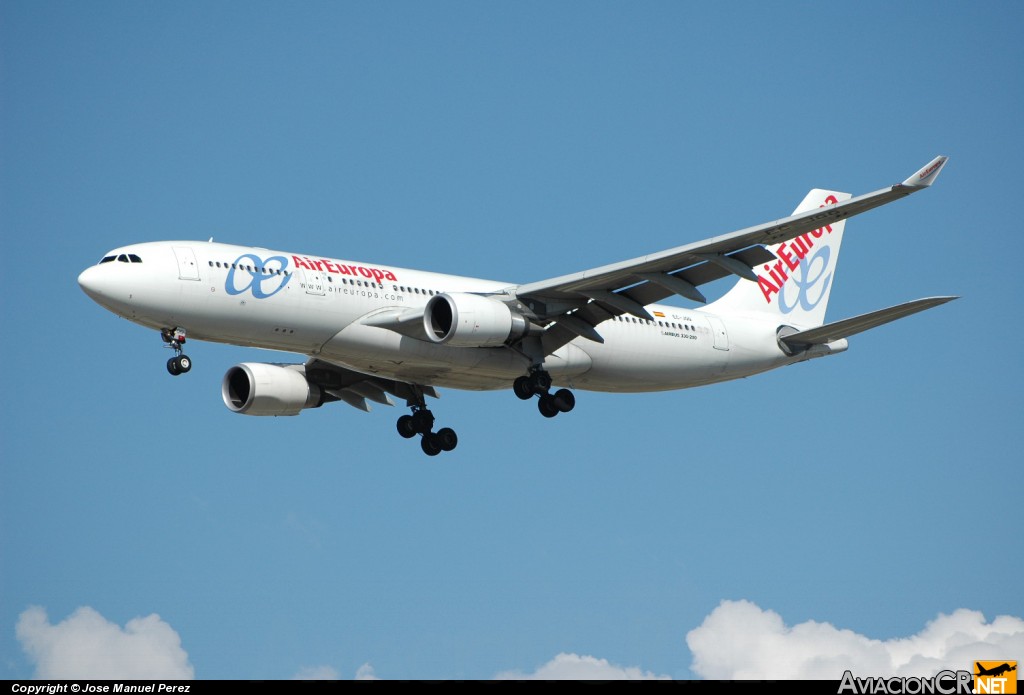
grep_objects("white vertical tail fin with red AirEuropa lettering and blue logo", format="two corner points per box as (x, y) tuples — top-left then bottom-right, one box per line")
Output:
(708, 188), (850, 327)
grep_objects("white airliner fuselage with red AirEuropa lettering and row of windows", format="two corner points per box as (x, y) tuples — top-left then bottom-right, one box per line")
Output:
(79, 242), (809, 392)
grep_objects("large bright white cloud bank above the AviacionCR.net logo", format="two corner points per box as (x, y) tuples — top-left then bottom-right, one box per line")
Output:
(686, 601), (1024, 680)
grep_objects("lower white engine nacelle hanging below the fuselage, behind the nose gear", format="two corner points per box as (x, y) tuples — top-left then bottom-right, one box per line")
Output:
(220, 362), (324, 416)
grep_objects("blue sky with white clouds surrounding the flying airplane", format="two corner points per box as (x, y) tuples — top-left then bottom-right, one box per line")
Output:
(0, 2), (1024, 679)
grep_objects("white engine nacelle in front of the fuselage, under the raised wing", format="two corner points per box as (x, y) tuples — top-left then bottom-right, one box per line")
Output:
(423, 293), (529, 347)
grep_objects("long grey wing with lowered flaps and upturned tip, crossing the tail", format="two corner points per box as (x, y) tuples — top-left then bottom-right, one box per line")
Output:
(516, 157), (947, 353)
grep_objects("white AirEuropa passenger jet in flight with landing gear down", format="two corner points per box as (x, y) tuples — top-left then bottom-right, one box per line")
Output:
(78, 157), (956, 455)
